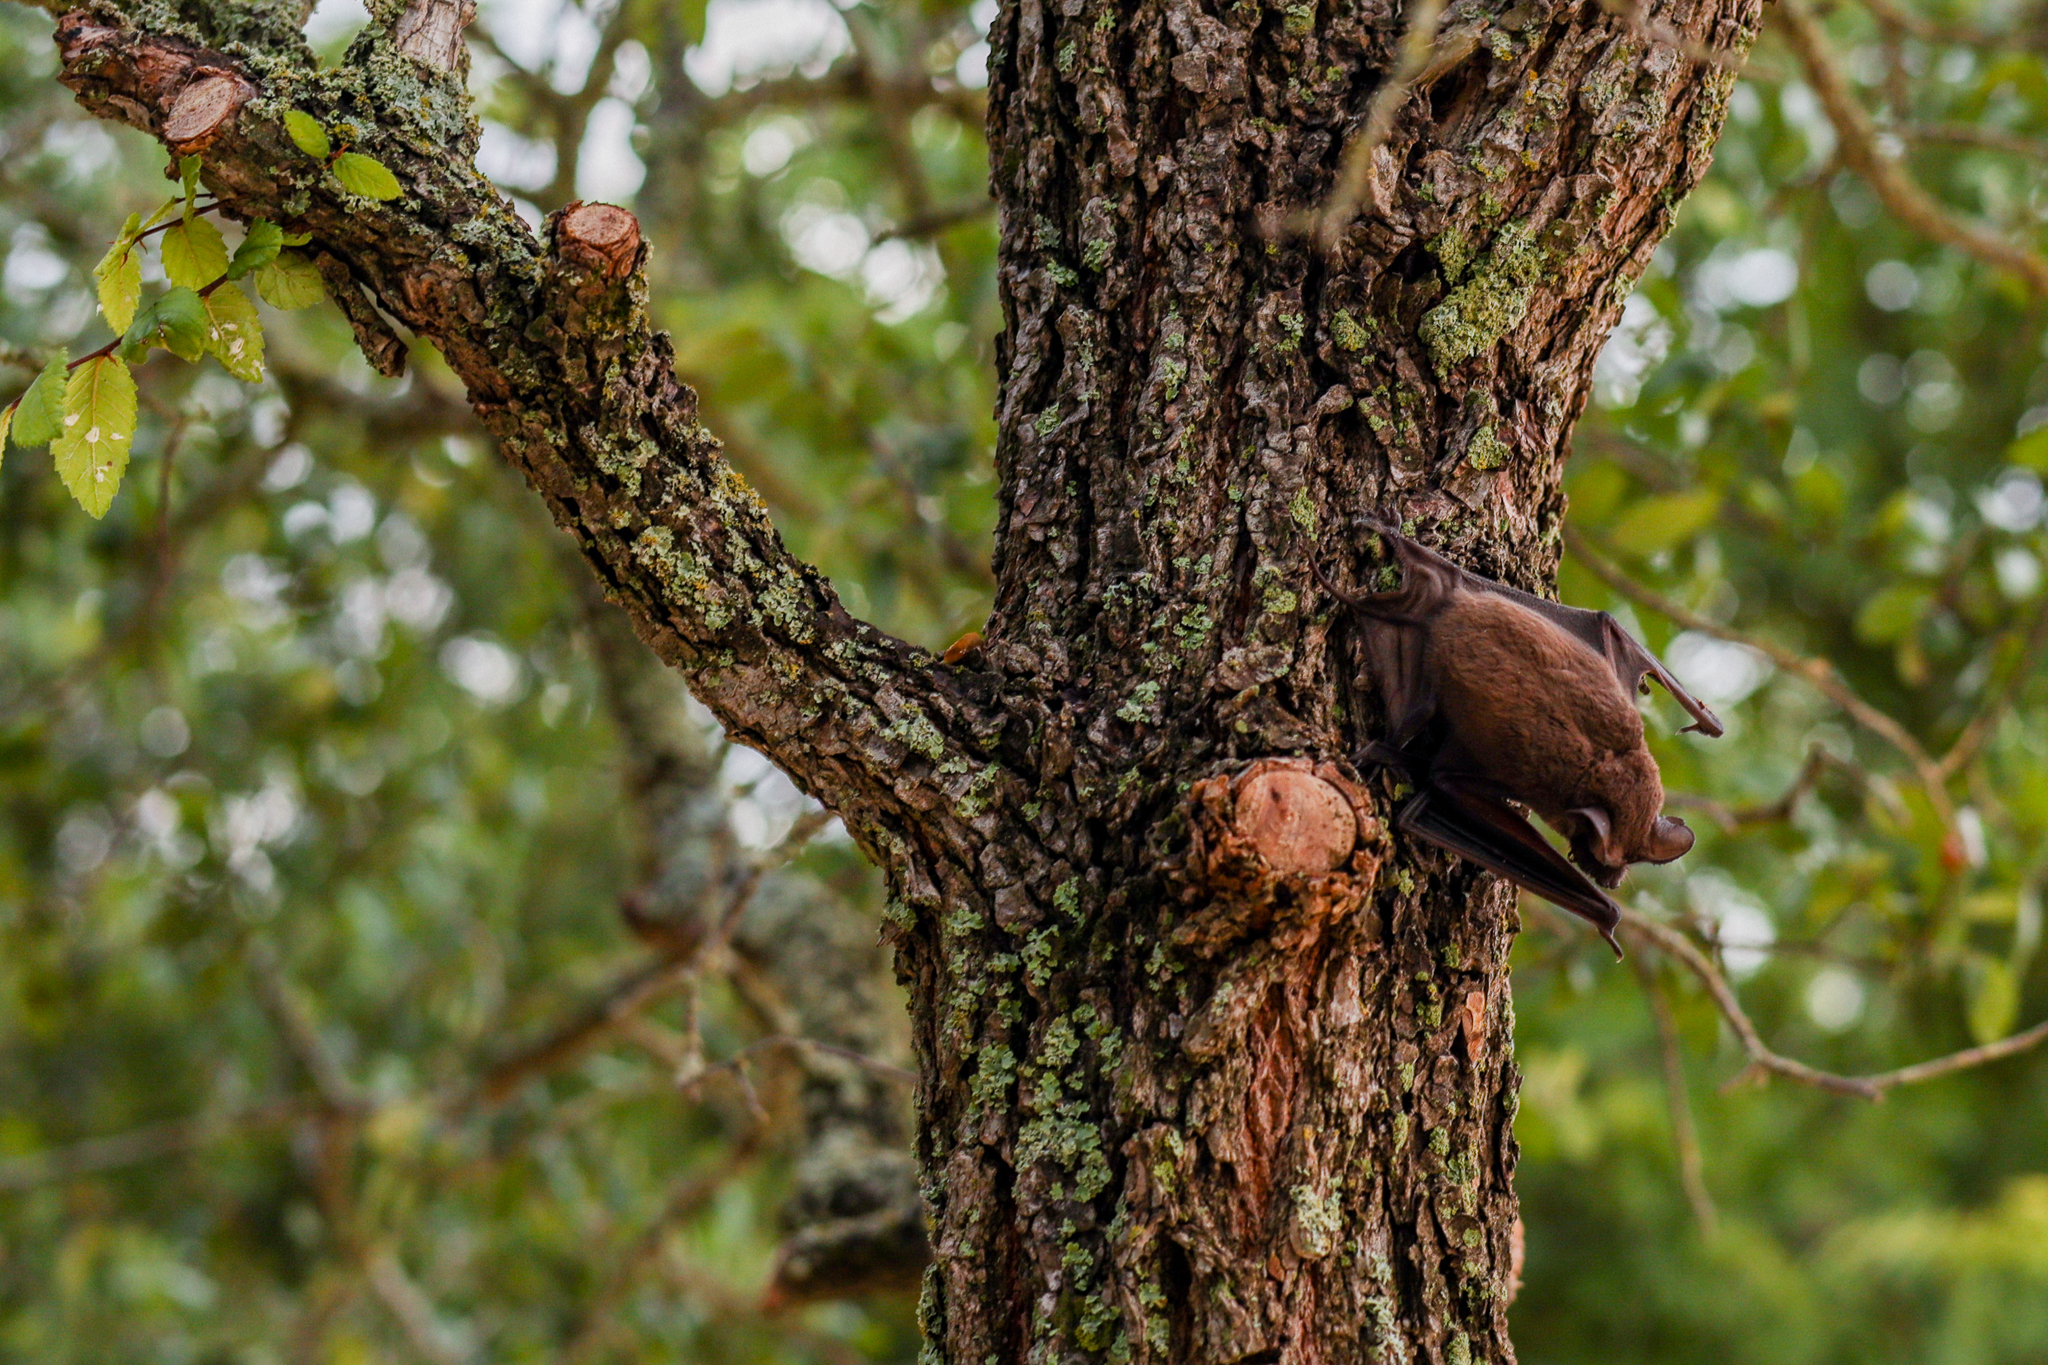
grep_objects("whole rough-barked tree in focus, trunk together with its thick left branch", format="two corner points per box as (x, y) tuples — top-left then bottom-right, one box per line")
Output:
(44, 0), (1757, 1365)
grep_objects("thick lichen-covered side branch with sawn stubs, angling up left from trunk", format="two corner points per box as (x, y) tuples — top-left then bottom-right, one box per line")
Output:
(39, 8), (1001, 862)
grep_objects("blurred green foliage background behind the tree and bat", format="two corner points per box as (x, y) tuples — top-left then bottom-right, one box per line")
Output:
(0, 0), (2048, 1365)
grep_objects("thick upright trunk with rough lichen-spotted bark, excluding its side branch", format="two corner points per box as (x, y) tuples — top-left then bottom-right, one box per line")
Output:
(903, 0), (1757, 1365)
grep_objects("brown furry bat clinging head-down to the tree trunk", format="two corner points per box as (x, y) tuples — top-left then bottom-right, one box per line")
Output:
(1309, 522), (1722, 956)
